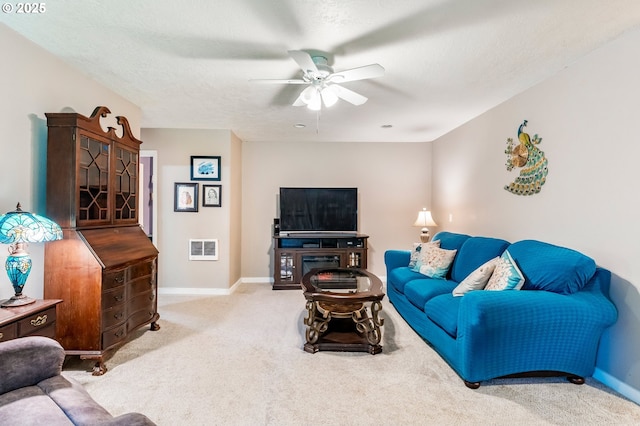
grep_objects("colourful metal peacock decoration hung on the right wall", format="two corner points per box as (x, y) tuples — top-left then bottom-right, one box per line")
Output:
(504, 120), (549, 195)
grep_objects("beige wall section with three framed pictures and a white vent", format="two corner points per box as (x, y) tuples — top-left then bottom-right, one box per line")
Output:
(142, 128), (242, 292)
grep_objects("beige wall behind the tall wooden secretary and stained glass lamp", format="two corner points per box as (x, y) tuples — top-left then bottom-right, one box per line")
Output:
(0, 24), (141, 299)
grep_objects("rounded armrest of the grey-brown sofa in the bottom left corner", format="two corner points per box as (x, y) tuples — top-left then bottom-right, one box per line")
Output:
(0, 336), (65, 394)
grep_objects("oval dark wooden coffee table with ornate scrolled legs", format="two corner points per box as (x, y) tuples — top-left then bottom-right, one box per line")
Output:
(302, 268), (384, 355)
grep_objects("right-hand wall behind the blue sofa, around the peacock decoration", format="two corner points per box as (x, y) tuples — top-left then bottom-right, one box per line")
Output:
(433, 31), (640, 402)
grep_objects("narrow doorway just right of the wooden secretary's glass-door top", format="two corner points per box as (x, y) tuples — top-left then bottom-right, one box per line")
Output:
(138, 150), (158, 247)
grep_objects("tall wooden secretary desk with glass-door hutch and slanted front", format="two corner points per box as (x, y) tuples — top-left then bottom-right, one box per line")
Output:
(44, 107), (159, 375)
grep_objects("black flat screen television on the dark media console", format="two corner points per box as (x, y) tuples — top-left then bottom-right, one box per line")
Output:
(280, 187), (358, 233)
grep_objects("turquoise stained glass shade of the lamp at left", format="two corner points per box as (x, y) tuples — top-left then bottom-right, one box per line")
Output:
(0, 203), (62, 244)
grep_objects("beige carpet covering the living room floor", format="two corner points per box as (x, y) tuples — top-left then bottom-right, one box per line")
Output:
(64, 284), (640, 426)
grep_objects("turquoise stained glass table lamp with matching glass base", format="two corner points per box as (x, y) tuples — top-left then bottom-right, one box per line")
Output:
(0, 203), (62, 308)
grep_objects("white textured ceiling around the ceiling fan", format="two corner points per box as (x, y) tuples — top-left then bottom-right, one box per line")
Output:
(0, 0), (640, 142)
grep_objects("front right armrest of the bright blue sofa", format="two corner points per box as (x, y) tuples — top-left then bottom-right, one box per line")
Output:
(457, 287), (617, 381)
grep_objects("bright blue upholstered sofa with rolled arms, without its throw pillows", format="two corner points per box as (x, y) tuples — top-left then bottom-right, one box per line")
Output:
(385, 232), (617, 389)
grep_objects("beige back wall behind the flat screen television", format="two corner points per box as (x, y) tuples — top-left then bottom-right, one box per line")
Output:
(242, 142), (431, 279)
